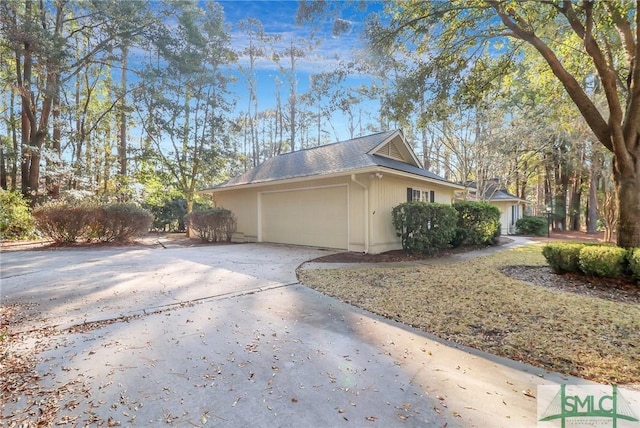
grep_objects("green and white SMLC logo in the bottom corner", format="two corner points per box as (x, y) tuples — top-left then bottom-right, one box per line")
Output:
(538, 385), (640, 428)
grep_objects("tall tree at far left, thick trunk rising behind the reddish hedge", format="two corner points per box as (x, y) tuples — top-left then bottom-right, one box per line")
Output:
(0, 0), (151, 201)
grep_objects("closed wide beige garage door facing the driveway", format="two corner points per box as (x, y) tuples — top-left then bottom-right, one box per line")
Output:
(261, 186), (348, 249)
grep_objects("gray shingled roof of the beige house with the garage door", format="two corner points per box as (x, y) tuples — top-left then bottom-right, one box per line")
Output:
(212, 131), (457, 189)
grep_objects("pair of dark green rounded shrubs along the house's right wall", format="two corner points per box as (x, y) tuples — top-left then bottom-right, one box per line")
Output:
(391, 202), (500, 255)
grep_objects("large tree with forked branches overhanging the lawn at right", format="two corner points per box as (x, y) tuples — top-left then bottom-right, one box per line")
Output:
(362, 0), (640, 247)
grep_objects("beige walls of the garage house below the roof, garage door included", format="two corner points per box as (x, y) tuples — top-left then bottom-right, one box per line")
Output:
(209, 173), (454, 254)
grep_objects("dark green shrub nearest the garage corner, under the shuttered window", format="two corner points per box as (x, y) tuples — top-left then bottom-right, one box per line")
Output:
(391, 202), (457, 255)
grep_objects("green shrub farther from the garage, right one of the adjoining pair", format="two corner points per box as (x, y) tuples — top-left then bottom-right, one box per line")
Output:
(453, 202), (500, 246)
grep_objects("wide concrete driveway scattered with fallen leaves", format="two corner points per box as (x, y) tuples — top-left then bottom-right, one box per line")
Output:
(1, 244), (579, 427)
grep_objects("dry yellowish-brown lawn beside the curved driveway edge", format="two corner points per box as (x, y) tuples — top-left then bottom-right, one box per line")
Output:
(299, 245), (640, 385)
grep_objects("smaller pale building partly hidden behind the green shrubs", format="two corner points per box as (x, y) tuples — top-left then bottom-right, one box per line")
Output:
(455, 179), (527, 235)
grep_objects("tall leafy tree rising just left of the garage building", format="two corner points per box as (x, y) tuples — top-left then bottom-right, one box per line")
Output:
(137, 2), (235, 227)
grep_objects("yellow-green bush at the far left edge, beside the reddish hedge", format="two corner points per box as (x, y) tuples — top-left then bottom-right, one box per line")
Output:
(0, 189), (35, 241)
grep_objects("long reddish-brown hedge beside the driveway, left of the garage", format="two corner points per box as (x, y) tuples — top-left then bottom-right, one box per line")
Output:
(33, 202), (153, 243)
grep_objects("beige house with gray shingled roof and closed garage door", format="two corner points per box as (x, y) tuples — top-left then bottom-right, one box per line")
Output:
(201, 131), (464, 254)
